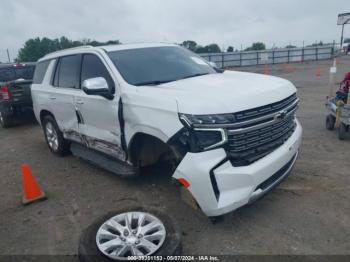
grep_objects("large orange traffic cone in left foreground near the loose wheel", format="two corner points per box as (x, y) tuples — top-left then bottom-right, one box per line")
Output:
(22, 164), (46, 205)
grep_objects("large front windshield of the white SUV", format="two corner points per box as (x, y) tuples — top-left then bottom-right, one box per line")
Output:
(108, 46), (216, 86)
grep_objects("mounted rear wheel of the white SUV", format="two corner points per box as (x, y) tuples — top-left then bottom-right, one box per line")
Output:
(42, 115), (69, 156)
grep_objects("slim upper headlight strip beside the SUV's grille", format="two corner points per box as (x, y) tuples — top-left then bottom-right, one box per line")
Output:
(179, 114), (236, 127)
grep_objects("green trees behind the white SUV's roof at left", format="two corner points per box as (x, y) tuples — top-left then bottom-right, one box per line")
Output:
(16, 36), (120, 62)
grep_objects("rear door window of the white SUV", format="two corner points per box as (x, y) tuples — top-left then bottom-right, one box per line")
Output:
(53, 55), (80, 88)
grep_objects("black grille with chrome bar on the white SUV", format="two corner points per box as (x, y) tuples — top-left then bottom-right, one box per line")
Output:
(226, 94), (298, 166)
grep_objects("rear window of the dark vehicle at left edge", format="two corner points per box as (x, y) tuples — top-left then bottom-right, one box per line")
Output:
(0, 65), (35, 82)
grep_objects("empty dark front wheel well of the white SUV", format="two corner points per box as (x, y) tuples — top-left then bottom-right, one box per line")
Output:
(128, 133), (176, 167)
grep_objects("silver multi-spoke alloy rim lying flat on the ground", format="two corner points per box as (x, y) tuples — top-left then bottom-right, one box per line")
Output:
(96, 212), (166, 260)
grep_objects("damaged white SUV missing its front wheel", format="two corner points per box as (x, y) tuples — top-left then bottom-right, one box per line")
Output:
(32, 44), (302, 217)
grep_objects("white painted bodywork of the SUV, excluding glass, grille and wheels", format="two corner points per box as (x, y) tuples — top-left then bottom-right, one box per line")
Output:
(32, 44), (302, 216)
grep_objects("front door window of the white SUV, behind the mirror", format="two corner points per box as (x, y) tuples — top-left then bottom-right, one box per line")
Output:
(80, 54), (114, 92)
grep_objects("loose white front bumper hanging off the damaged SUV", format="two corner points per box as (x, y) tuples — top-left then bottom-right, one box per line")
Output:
(173, 121), (302, 216)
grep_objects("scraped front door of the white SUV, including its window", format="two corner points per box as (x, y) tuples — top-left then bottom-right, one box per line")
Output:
(75, 53), (125, 160)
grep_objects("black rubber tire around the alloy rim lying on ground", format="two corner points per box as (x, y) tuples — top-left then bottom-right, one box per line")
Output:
(78, 206), (182, 262)
